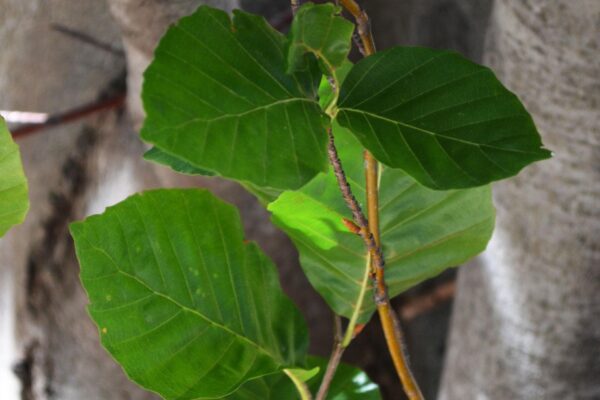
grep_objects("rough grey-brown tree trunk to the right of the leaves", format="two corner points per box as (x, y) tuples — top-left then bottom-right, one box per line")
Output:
(440, 0), (600, 400)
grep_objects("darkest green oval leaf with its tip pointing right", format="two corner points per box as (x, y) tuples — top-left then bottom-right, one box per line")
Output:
(337, 47), (550, 189)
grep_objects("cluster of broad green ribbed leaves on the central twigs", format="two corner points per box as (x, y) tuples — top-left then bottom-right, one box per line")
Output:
(68, 3), (550, 400)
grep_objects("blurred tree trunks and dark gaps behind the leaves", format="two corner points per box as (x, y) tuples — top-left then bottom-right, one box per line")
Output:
(0, 0), (600, 400)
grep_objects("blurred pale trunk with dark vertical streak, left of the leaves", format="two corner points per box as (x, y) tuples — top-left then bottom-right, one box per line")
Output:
(0, 0), (243, 400)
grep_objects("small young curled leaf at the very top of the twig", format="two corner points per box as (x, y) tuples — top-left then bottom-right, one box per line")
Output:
(288, 3), (354, 82)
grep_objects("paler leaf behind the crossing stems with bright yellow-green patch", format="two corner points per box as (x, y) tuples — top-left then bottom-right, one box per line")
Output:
(269, 124), (495, 322)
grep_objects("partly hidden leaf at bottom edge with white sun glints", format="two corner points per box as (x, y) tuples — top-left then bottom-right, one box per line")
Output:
(226, 357), (381, 400)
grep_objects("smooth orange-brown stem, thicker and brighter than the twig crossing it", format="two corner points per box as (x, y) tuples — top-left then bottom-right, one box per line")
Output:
(340, 0), (423, 400)
